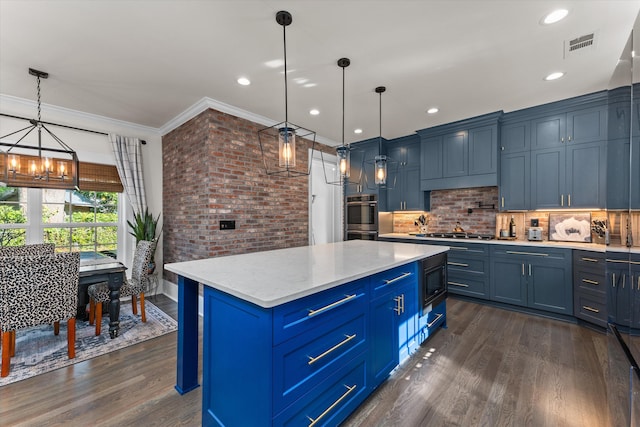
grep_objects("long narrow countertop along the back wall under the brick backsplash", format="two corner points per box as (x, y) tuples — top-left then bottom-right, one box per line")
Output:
(378, 233), (640, 253)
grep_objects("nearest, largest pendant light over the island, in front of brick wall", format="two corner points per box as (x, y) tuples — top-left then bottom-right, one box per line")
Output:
(258, 10), (316, 177)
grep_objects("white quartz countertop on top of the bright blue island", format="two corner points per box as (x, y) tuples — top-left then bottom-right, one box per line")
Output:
(164, 240), (449, 308)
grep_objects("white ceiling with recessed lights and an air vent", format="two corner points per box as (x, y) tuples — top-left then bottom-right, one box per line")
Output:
(0, 0), (640, 143)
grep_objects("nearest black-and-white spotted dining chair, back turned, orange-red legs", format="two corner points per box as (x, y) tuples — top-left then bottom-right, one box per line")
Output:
(0, 252), (80, 377)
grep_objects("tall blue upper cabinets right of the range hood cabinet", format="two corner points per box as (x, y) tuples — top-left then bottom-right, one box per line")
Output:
(500, 92), (607, 210)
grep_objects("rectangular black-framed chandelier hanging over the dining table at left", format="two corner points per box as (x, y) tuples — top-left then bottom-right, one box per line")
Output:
(0, 68), (79, 189)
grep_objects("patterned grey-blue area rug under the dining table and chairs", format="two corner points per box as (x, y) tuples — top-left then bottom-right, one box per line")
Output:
(0, 300), (178, 387)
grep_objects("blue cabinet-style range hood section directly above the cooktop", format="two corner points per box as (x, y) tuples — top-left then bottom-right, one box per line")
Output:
(417, 112), (502, 191)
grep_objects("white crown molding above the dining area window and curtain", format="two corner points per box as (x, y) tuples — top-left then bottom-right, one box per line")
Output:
(0, 94), (160, 135)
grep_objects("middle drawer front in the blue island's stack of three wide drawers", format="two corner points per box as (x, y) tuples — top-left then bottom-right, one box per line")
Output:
(273, 314), (366, 413)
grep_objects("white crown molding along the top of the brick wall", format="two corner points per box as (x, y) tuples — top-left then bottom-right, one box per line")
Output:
(160, 97), (340, 147)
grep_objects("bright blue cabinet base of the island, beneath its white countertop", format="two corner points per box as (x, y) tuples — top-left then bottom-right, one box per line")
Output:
(202, 262), (445, 426)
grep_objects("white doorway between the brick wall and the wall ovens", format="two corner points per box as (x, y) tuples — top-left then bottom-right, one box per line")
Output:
(309, 150), (343, 245)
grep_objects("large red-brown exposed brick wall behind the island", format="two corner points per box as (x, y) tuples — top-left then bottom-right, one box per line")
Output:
(162, 109), (335, 283)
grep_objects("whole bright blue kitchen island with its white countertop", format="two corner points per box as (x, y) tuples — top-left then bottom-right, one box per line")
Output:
(165, 240), (448, 426)
